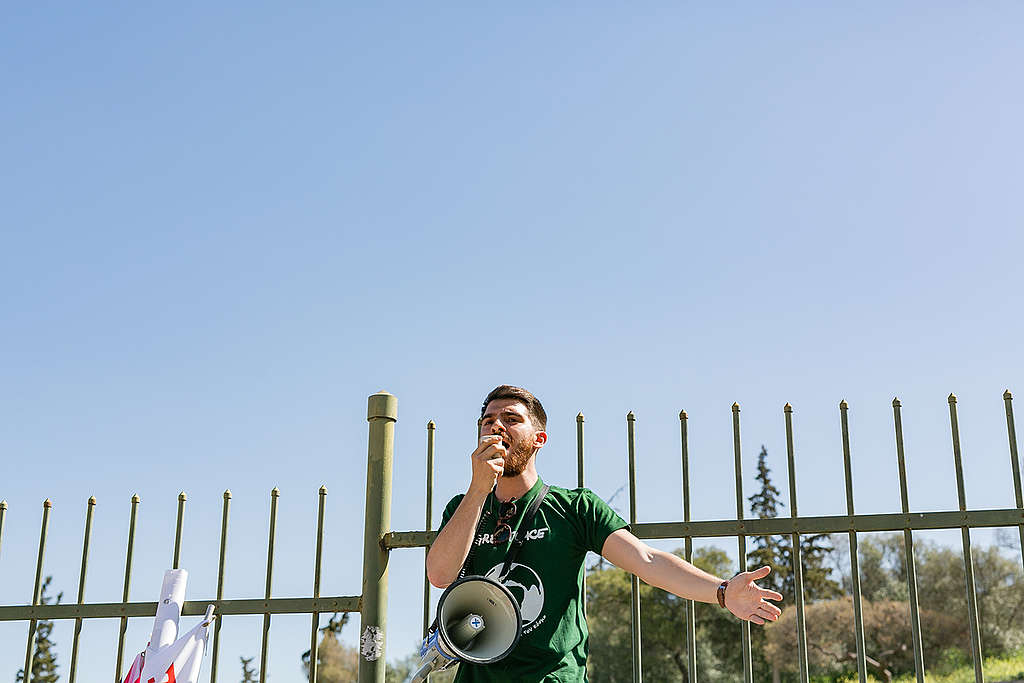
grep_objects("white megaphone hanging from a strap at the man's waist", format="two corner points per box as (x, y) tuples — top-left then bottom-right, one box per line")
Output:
(409, 577), (522, 683)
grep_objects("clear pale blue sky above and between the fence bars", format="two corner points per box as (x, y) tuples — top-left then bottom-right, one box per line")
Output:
(0, 2), (1024, 681)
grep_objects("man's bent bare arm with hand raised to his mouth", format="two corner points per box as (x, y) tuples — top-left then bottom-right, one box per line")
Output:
(427, 434), (506, 588)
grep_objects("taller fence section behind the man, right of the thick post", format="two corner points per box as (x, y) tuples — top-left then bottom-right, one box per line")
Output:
(384, 390), (1024, 683)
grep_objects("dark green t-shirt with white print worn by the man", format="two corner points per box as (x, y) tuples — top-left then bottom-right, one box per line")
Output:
(441, 479), (628, 683)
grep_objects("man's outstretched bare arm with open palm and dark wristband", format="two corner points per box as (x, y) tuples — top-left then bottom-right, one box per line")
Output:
(601, 528), (782, 624)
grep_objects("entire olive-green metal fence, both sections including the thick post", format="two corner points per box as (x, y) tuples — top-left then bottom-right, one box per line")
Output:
(0, 391), (1024, 683)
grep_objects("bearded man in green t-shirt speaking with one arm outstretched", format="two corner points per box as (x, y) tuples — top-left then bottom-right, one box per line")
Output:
(427, 385), (782, 683)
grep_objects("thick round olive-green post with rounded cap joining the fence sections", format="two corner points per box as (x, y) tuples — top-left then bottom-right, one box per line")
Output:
(359, 391), (398, 683)
